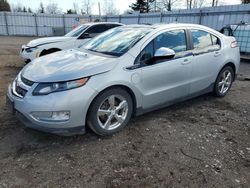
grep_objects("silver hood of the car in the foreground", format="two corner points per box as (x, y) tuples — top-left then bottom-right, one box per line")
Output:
(21, 49), (117, 82)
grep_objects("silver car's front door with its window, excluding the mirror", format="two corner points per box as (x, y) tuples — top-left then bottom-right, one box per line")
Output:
(139, 30), (193, 109)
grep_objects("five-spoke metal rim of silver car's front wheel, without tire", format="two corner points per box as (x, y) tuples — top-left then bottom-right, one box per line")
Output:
(97, 95), (128, 130)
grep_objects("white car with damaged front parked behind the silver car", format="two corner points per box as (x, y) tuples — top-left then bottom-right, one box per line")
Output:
(20, 22), (123, 63)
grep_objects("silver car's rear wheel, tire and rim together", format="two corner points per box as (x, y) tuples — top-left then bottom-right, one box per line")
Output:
(214, 66), (235, 97)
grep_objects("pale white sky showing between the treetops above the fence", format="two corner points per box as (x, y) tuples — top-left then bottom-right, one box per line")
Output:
(8, 0), (240, 14)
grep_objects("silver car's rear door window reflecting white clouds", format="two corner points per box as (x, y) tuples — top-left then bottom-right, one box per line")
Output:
(191, 30), (213, 49)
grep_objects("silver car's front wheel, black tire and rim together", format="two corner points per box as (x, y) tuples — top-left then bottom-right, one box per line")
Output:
(87, 88), (133, 136)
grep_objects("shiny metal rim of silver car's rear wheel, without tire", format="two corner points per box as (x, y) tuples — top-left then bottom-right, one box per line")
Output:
(218, 70), (232, 94)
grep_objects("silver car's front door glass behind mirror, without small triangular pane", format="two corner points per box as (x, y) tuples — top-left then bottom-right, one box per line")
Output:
(154, 30), (187, 53)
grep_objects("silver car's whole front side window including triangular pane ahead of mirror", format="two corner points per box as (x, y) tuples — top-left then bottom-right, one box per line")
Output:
(135, 30), (187, 64)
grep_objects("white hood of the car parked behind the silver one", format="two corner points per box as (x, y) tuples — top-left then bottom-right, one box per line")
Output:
(27, 36), (74, 47)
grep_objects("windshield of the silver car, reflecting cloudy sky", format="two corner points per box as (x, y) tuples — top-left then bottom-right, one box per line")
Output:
(83, 27), (152, 56)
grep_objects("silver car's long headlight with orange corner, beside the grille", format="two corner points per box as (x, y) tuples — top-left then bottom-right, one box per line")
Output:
(32, 78), (89, 95)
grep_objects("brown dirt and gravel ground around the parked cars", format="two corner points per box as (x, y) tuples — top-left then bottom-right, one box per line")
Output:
(0, 37), (250, 188)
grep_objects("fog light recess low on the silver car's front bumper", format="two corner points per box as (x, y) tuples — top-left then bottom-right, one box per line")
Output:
(31, 111), (70, 122)
